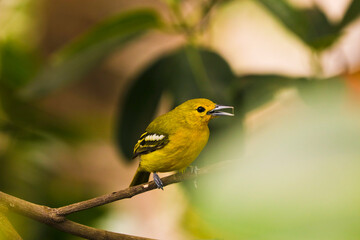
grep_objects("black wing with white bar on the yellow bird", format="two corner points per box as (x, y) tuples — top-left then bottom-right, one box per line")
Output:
(132, 132), (169, 158)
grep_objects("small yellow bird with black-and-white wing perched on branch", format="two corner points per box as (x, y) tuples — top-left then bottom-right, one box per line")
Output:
(130, 98), (234, 190)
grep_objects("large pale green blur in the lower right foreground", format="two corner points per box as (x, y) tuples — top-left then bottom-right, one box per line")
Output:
(188, 101), (360, 240)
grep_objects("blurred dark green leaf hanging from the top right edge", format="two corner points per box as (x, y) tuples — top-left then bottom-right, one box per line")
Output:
(258, 0), (341, 50)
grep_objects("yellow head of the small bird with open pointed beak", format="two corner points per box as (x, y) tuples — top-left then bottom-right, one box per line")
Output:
(176, 98), (234, 125)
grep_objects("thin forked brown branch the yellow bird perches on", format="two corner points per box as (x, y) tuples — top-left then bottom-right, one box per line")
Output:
(0, 162), (228, 240)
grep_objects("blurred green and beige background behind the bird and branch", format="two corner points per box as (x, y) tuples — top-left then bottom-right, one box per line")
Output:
(0, 0), (360, 240)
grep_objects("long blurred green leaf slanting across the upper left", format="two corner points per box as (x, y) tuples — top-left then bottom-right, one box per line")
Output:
(21, 10), (161, 98)
